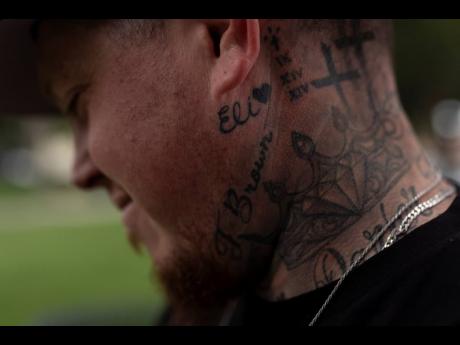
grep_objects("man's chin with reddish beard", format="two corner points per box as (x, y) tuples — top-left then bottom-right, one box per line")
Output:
(138, 212), (268, 310)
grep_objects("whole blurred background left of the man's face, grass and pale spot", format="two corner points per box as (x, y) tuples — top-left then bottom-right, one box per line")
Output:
(0, 117), (165, 325)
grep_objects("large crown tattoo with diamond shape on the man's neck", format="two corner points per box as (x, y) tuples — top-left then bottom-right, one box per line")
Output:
(271, 102), (409, 269)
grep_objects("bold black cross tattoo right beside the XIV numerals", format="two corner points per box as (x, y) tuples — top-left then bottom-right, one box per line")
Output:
(311, 42), (360, 110)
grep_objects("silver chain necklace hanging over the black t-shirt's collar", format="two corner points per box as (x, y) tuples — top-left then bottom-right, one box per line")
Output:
(308, 173), (455, 326)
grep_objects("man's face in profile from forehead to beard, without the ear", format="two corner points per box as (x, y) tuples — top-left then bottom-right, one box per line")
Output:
(38, 21), (274, 305)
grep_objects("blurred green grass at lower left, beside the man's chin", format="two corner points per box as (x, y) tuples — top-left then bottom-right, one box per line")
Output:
(0, 184), (167, 325)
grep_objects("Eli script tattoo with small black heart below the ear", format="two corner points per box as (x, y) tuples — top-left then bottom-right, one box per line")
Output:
(217, 83), (271, 134)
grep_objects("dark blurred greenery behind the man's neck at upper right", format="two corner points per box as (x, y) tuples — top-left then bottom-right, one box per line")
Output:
(394, 19), (460, 132)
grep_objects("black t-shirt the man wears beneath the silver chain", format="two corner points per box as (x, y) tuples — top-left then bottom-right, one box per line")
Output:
(230, 187), (460, 326)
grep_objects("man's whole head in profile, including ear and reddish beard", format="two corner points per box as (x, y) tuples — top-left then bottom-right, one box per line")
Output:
(37, 20), (395, 305)
